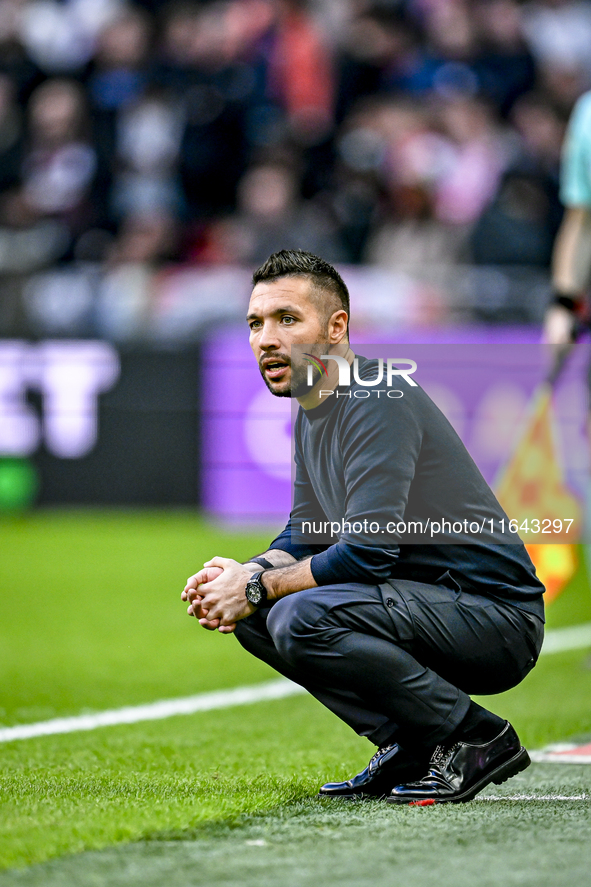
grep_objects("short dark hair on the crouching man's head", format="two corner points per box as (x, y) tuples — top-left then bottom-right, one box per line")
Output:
(252, 249), (350, 328)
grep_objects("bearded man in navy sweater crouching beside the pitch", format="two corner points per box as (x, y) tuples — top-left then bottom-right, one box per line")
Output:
(182, 250), (544, 804)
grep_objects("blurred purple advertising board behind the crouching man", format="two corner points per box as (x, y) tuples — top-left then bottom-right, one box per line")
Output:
(202, 327), (589, 527)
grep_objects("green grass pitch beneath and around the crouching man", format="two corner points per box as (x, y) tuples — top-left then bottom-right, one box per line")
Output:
(0, 511), (591, 887)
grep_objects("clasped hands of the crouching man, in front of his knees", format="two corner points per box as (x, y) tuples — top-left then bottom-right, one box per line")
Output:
(181, 557), (256, 634)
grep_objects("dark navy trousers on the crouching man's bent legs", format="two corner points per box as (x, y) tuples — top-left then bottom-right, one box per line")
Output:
(236, 580), (544, 748)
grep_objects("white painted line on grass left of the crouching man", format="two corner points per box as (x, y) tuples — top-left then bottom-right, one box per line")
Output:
(0, 678), (306, 742)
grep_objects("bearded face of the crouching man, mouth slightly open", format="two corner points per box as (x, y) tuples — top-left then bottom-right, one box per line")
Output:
(247, 276), (329, 397)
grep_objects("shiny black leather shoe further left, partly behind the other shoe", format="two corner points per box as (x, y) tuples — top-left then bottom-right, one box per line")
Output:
(318, 743), (426, 800)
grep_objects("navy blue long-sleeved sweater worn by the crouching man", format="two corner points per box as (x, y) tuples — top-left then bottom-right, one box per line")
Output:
(269, 357), (544, 616)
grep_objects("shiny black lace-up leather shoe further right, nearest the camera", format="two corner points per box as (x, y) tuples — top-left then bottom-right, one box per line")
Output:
(387, 721), (531, 804)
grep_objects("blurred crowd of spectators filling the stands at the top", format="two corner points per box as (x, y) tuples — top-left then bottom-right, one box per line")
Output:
(0, 0), (591, 273)
